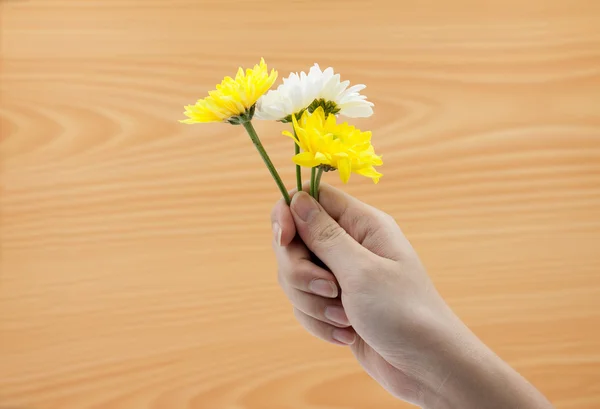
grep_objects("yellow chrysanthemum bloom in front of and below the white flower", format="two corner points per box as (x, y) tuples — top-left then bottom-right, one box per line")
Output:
(283, 107), (383, 183)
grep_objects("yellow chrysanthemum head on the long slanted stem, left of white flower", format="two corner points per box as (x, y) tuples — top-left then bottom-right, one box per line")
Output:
(180, 58), (277, 124)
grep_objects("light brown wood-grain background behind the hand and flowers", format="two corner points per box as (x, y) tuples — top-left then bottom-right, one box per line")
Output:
(0, 0), (600, 409)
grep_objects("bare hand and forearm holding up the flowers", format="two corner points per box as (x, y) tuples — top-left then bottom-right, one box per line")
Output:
(271, 185), (553, 409)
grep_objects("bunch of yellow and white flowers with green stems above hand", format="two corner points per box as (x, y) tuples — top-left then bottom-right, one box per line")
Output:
(180, 59), (383, 204)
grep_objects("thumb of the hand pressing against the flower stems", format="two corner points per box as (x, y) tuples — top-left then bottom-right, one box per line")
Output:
(290, 192), (372, 278)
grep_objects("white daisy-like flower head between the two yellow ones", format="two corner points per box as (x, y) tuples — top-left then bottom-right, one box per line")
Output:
(256, 64), (373, 122)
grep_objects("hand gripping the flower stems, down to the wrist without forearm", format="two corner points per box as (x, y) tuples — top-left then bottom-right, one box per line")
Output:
(273, 185), (452, 404)
